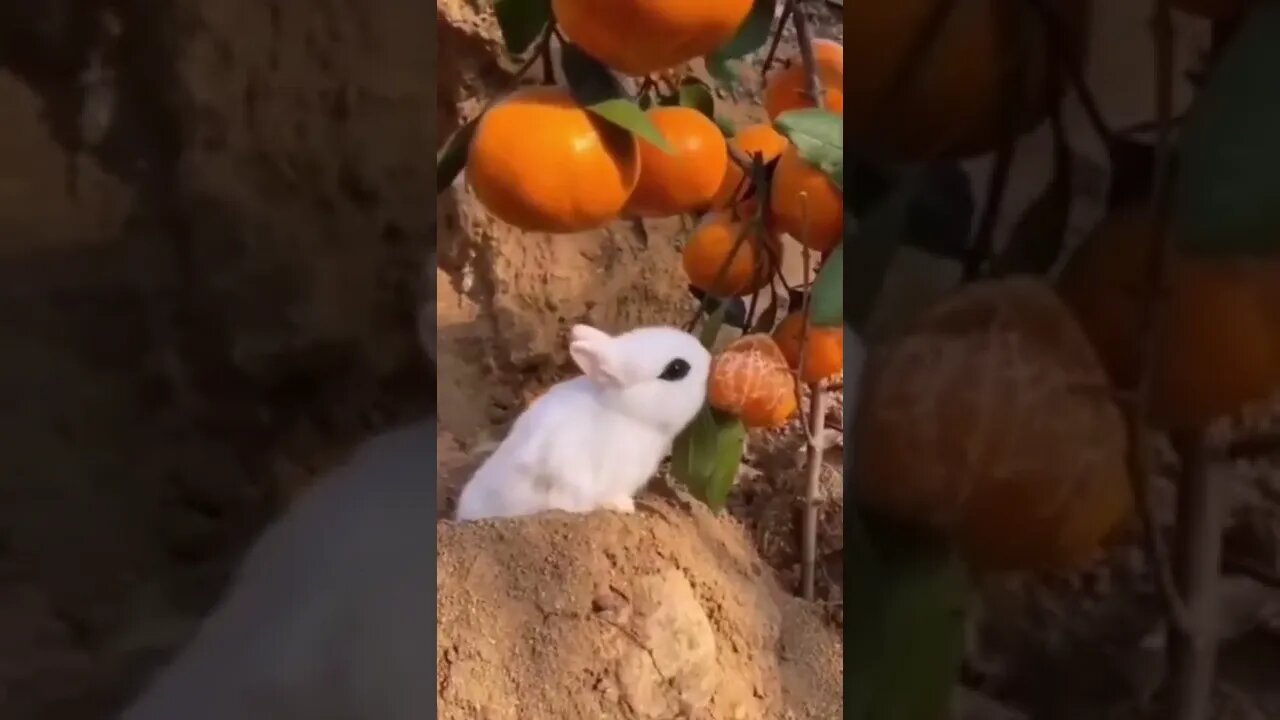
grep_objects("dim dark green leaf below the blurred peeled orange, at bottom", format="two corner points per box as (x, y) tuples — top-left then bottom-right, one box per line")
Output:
(845, 509), (970, 720)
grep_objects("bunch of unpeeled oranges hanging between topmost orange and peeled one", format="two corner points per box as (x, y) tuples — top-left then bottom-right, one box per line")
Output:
(467, 38), (844, 252)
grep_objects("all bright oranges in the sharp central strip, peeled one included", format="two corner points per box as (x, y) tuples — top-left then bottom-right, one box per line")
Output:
(466, 0), (844, 435)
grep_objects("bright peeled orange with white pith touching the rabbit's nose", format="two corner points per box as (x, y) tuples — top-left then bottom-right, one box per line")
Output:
(707, 333), (797, 428)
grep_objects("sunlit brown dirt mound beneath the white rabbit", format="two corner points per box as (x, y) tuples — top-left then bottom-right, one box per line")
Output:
(436, 500), (844, 720)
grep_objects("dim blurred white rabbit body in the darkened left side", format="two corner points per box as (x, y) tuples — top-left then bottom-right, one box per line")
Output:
(120, 420), (436, 720)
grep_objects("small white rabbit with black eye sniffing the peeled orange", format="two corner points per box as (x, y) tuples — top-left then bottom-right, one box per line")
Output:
(457, 325), (710, 520)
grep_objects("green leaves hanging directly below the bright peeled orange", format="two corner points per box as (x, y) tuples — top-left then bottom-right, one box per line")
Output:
(671, 407), (746, 510)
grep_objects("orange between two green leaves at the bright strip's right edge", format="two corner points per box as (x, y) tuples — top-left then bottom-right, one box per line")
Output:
(769, 145), (845, 252)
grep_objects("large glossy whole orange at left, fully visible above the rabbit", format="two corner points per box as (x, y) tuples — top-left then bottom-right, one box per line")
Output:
(466, 87), (640, 233)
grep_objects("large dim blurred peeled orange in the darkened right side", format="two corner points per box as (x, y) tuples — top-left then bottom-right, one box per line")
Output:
(854, 277), (1133, 571)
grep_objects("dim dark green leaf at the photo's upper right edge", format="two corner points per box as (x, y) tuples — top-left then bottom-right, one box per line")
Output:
(1172, 0), (1280, 255)
